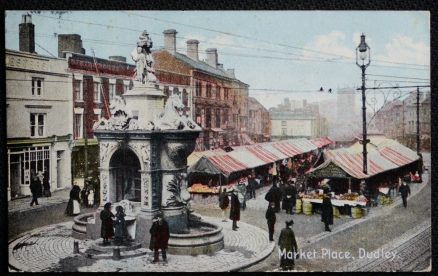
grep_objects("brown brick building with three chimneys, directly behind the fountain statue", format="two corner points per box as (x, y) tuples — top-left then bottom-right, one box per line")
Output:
(152, 30), (250, 150)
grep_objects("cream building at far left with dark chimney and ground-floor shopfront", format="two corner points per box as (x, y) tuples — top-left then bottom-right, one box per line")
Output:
(5, 15), (73, 200)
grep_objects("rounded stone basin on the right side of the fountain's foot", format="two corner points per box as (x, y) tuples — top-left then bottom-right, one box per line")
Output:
(168, 221), (224, 255)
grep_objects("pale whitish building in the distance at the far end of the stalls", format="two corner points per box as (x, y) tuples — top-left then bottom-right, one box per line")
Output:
(269, 99), (328, 141)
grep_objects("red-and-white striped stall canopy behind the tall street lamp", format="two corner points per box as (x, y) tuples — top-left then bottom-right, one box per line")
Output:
(307, 138), (419, 179)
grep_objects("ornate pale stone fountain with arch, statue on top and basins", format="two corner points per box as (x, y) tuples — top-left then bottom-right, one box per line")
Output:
(73, 31), (224, 255)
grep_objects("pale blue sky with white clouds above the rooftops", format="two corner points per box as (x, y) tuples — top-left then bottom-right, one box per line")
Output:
(5, 11), (430, 112)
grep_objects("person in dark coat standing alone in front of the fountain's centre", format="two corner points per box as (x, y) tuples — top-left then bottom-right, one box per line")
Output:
(149, 213), (170, 263)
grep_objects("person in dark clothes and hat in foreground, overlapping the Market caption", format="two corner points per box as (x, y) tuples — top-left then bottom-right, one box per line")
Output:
(278, 220), (298, 270)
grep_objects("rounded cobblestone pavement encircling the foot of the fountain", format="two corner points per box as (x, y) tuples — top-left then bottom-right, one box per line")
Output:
(9, 218), (274, 272)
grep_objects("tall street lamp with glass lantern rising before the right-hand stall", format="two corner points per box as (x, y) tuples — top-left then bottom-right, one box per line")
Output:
(356, 34), (371, 174)
